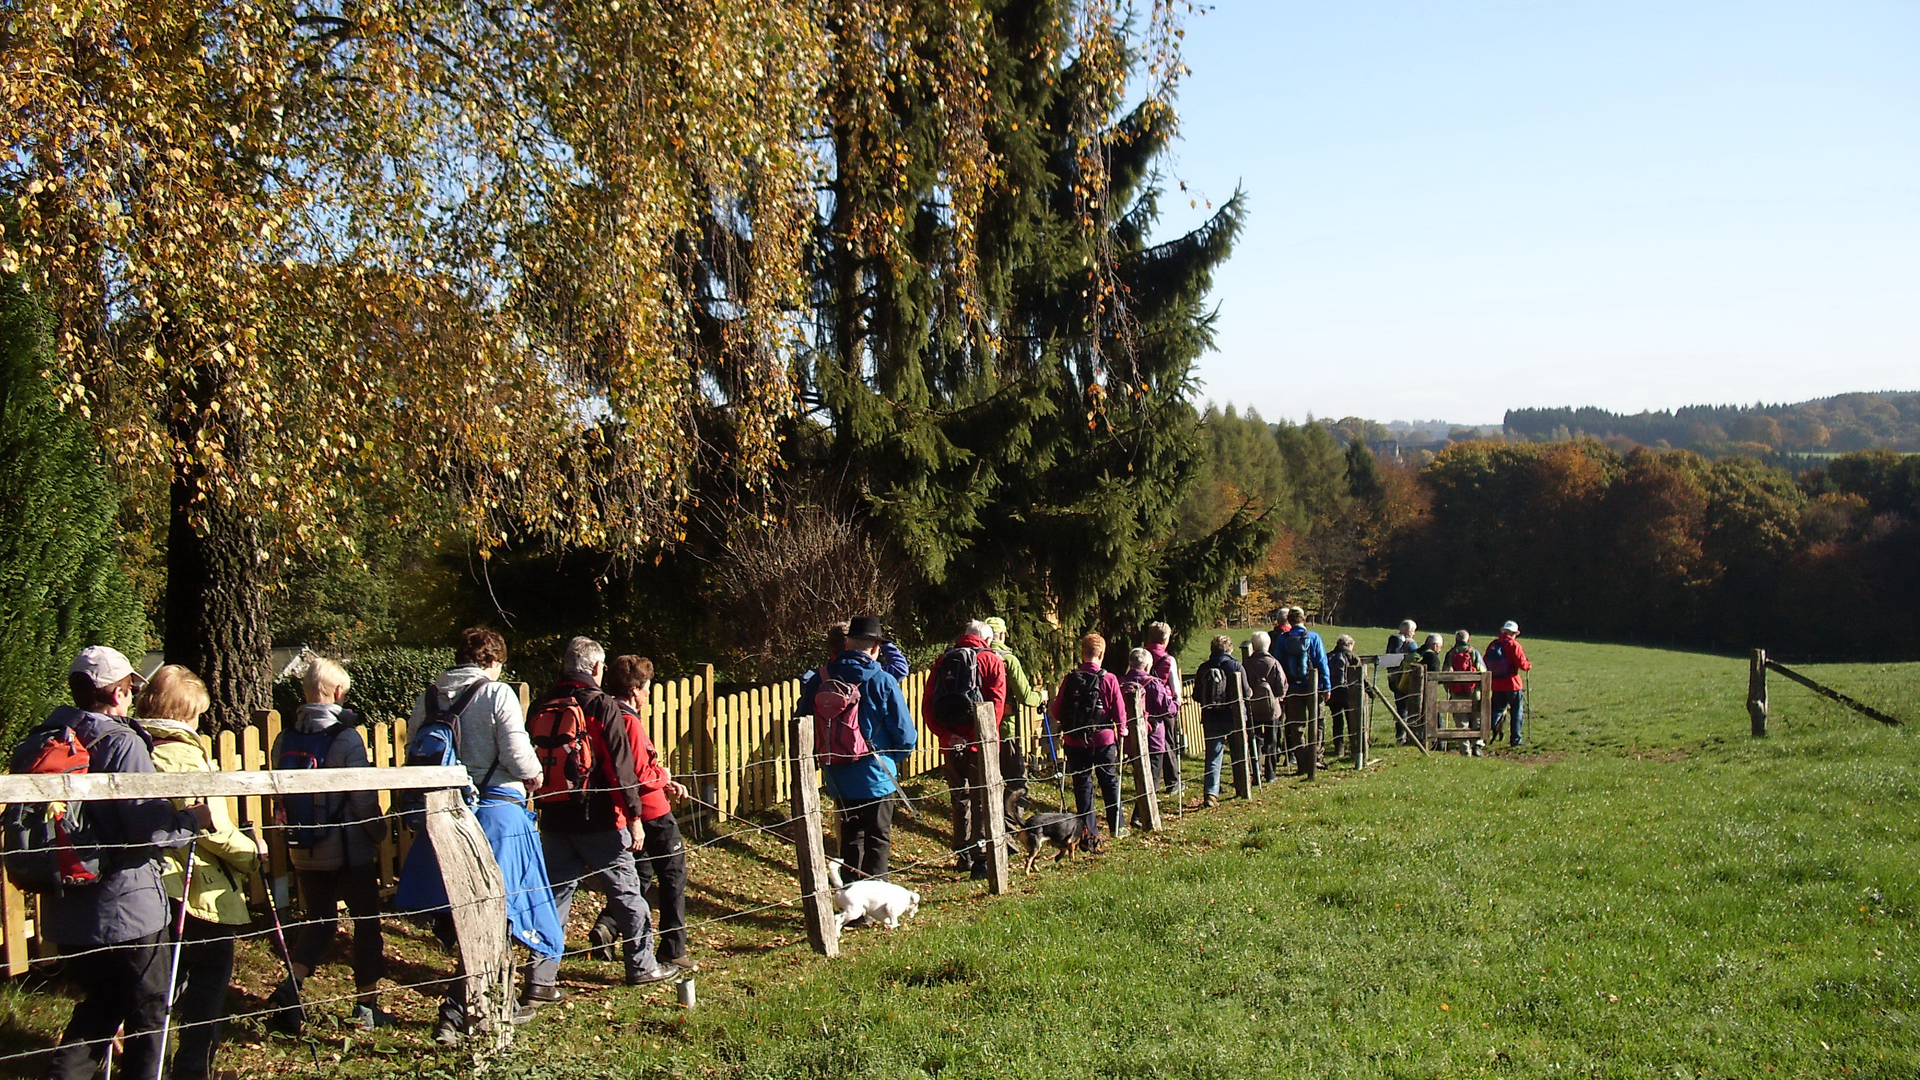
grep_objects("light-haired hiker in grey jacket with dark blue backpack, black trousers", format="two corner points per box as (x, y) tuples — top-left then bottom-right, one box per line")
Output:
(267, 657), (394, 1034)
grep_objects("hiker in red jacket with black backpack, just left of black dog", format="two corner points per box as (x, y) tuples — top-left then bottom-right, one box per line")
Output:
(920, 621), (1006, 878)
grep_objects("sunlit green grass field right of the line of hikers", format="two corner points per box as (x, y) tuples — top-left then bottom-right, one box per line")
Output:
(6, 630), (1920, 1080)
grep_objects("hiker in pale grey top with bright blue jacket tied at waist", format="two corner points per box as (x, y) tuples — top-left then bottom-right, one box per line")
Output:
(394, 626), (566, 1045)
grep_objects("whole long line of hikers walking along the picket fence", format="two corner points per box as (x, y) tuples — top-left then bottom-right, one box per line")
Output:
(0, 607), (1532, 1080)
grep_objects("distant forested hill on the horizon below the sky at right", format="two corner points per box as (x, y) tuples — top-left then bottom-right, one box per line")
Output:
(1505, 392), (1920, 457)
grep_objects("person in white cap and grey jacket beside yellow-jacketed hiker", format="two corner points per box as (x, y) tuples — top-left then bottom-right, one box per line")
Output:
(12, 646), (213, 1080)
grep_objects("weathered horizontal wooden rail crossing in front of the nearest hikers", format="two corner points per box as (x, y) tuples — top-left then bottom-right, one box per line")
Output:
(0, 765), (472, 803)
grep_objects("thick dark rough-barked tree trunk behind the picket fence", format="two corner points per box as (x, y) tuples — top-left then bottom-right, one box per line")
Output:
(167, 473), (273, 730)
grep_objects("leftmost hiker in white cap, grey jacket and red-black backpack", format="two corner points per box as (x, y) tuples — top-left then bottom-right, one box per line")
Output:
(6, 646), (213, 1080)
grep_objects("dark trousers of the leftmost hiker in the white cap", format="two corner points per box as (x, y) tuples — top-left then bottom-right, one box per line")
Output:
(46, 930), (173, 1080)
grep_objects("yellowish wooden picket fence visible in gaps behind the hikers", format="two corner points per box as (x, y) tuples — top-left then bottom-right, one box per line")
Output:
(0, 665), (1202, 976)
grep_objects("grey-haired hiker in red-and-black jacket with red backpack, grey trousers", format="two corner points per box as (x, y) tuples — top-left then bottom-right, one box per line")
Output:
(520, 638), (680, 1005)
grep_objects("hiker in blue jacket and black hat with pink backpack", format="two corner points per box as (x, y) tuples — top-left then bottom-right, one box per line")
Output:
(793, 615), (918, 880)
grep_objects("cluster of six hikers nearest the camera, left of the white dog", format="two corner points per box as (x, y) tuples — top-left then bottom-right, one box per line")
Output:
(4, 626), (699, 1080)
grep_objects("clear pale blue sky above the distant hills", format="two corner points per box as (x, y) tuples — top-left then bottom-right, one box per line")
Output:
(1164, 0), (1920, 423)
